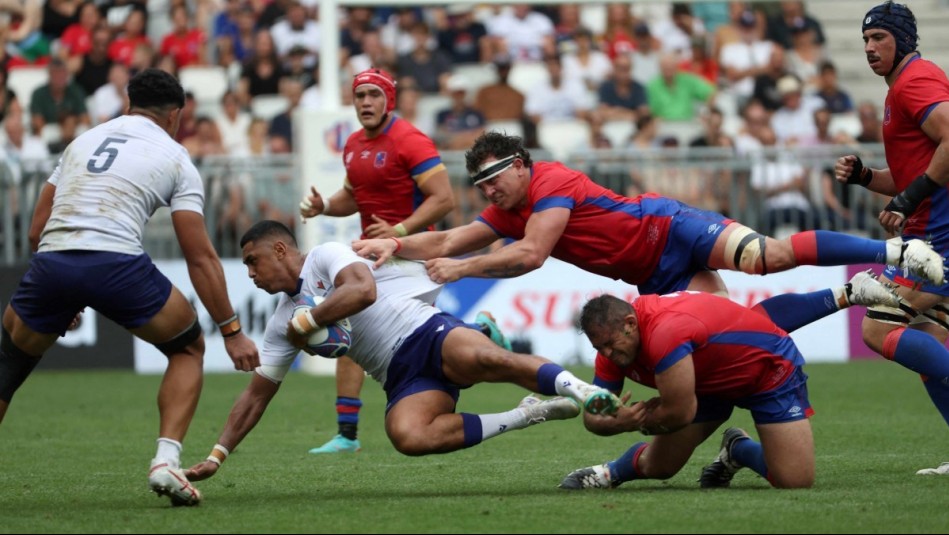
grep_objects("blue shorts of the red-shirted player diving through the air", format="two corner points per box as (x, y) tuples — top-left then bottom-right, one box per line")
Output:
(639, 205), (733, 295)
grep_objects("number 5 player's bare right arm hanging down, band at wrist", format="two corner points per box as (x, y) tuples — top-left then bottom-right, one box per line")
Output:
(171, 210), (260, 371)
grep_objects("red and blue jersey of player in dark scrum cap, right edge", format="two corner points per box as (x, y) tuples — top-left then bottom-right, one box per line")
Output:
(883, 56), (949, 237)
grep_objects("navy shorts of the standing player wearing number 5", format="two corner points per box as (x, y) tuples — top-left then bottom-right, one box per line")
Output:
(10, 251), (171, 336)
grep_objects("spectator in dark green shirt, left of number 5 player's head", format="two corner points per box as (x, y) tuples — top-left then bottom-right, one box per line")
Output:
(30, 58), (89, 135)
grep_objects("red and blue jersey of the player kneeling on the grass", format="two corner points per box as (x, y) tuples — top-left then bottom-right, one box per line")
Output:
(594, 292), (804, 399)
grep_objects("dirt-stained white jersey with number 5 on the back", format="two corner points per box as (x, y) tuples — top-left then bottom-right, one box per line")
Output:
(39, 115), (204, 255)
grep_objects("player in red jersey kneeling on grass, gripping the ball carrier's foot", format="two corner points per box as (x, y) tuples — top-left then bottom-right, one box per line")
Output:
(560, 280), (896, 489)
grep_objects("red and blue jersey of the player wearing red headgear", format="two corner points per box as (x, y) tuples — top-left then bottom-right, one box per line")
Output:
(343, 117), (445, 238)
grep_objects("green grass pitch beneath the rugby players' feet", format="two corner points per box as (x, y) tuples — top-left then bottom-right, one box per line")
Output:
(0, 361), (949, 533)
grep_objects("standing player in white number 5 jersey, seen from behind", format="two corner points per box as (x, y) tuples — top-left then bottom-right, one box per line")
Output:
(0, 69), (259, 505)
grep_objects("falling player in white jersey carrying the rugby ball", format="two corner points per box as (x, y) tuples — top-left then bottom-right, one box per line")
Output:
(186, 221), (619, 481)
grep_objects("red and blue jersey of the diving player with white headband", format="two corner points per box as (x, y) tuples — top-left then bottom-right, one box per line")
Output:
(478, 162), (682, 284)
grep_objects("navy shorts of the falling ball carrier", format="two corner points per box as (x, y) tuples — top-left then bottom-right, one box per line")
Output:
(383, 312), (474, 413)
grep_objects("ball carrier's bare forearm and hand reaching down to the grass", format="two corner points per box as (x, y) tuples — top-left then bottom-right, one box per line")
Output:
(185, 373), (280, 481)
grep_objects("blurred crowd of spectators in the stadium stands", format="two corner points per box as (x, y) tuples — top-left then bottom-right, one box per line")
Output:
(0, 0), (881, 238)
